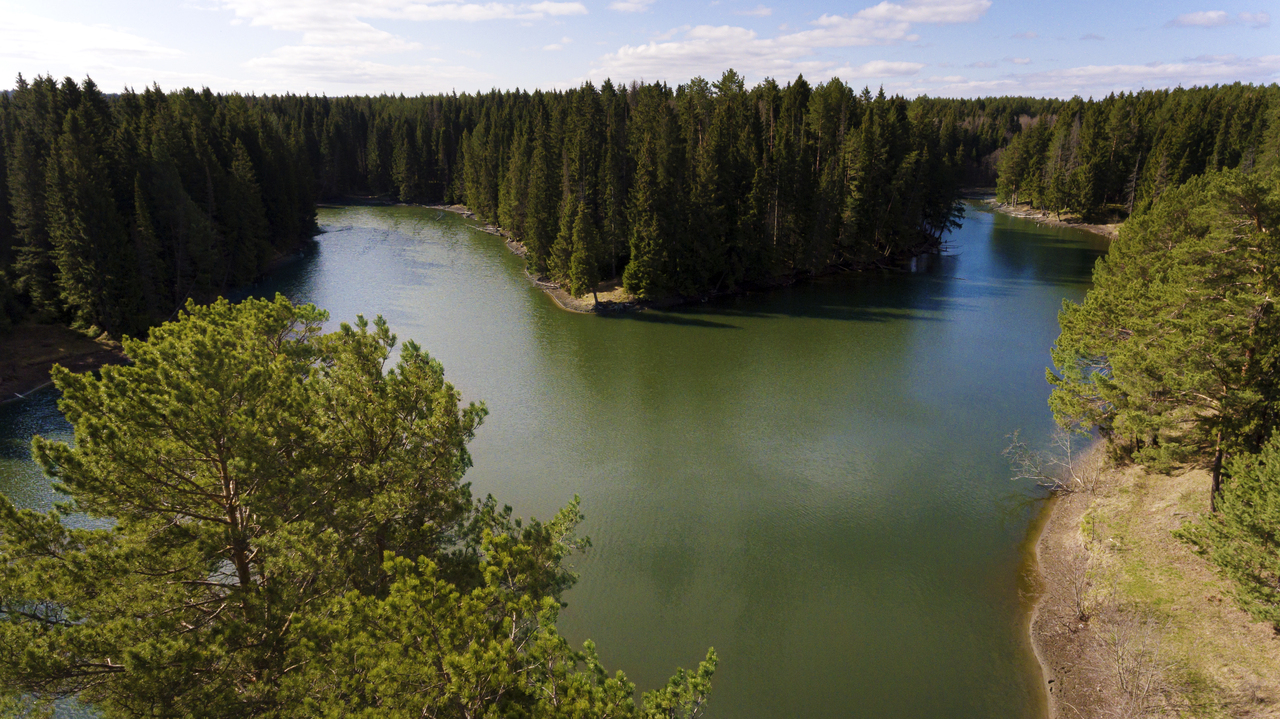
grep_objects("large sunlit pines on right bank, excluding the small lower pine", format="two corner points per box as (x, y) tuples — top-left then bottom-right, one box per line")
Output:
(1048, 165), (1280, 463)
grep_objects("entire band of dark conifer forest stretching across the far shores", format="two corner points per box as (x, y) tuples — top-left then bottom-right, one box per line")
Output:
(10, 70), (1280, 335)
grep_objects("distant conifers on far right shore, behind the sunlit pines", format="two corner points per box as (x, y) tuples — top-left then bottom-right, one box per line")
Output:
(993, 83), (1280, 220)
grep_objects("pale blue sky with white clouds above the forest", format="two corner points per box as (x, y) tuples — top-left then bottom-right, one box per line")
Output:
(0, 0), (1280, 97)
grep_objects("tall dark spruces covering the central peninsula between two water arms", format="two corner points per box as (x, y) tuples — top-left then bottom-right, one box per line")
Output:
(268, 70), (961, 303)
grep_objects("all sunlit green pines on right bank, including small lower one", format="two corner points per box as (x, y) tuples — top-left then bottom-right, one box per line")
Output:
(1048, 162), (1280, 629)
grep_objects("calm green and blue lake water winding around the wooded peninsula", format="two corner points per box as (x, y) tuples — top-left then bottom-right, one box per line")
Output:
(0, 206), (1106, 719)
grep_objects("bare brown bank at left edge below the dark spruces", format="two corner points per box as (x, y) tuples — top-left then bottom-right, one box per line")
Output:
(0, 324), (128, 403)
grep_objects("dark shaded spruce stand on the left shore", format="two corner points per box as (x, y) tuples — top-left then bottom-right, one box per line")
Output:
(0, 75), (315, 336)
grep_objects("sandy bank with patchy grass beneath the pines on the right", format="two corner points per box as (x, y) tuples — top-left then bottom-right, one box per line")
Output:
(1030, 446), (1280, 719)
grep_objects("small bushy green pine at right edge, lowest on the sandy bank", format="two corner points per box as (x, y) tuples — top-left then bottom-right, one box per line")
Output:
(1175, 438), (1280, 631)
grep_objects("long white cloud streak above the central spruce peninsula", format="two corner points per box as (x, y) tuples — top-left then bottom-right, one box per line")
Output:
(590, 0), (991, 81)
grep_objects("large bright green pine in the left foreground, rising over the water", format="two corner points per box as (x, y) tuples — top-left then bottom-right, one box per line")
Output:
(0, 298), (716, 716)
